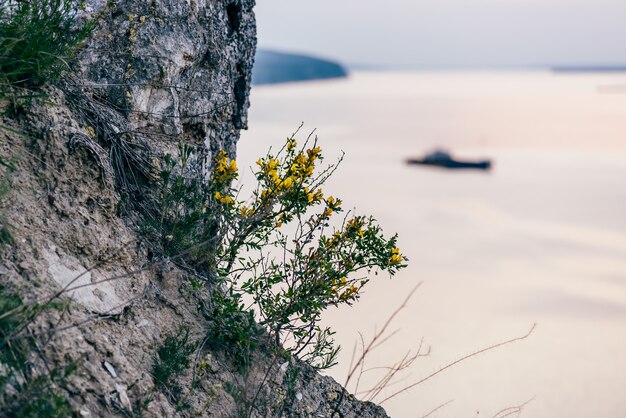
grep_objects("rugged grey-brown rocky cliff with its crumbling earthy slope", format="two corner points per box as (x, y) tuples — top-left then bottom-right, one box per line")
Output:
(0, 0), (386, 417)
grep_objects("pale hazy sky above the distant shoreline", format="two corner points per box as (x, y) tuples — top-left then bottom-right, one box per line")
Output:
(255, 0), (626, 68)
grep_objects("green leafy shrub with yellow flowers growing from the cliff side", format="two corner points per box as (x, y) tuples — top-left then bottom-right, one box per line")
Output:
(151, 134), (406, 369)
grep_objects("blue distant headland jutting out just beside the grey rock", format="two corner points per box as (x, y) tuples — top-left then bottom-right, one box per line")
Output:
(252, 50), (348, 84)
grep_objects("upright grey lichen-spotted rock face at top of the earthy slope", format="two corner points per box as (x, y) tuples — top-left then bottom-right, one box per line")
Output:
(79, 0), (256, 157)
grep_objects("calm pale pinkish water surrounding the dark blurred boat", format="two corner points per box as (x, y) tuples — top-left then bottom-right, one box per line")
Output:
(238, 72), (626, 418)
